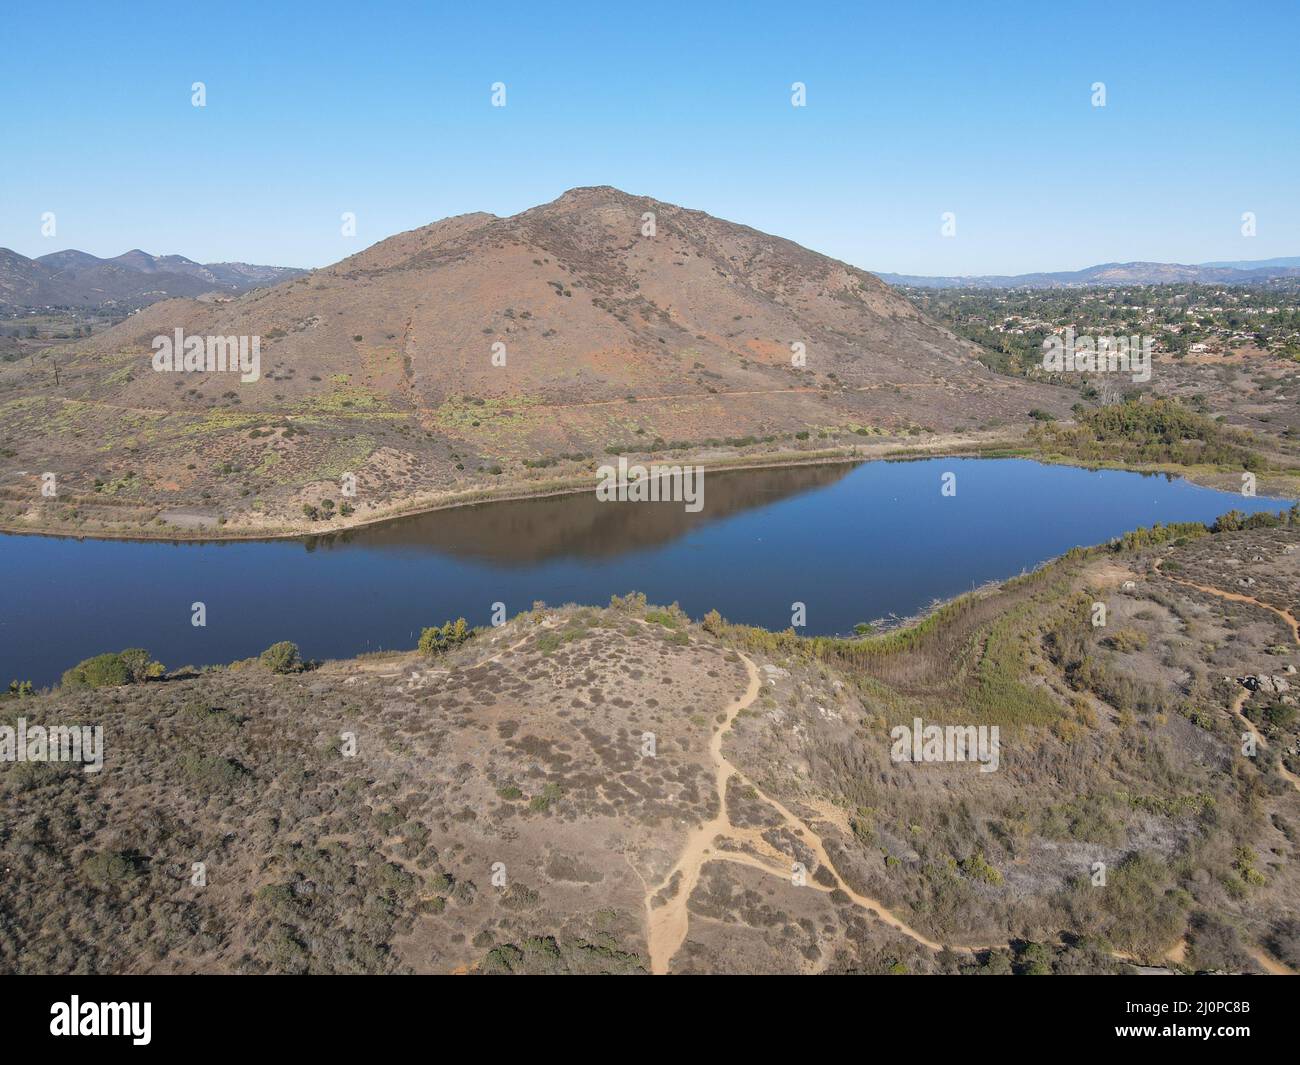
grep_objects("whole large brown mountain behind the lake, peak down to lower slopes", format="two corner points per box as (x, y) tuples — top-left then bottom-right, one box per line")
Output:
(0, 187), (1076, 540)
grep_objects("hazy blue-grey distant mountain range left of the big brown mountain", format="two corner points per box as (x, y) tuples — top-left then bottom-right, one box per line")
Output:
(0, 248), (306, 313)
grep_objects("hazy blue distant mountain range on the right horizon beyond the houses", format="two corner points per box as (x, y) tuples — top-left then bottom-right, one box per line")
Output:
(876, 256), (1300, 289)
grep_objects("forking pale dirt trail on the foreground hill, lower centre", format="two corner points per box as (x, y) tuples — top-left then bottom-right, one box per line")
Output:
(646, 654), (1006, 974)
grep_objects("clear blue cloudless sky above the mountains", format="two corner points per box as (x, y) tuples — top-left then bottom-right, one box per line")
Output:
(0, 0), (1300, 273)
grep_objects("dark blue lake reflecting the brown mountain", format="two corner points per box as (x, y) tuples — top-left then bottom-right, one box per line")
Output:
(0, 459), (1290, 687)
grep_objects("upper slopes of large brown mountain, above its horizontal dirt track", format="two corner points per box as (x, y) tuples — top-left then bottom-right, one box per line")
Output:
(63, 187), (1066, 418)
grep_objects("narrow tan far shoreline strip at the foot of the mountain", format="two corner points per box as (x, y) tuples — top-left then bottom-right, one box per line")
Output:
(0, 440), (1300, 544)
